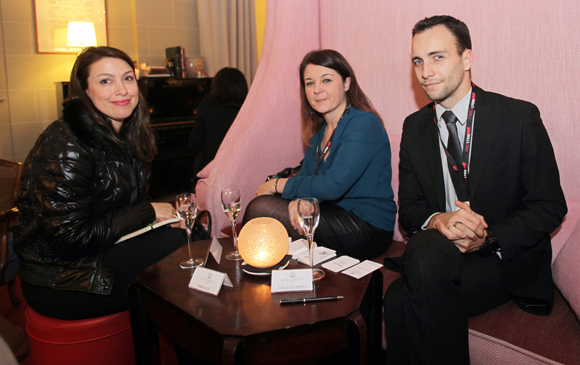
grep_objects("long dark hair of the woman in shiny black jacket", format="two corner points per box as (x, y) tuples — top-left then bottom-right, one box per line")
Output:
(63, 47), (157, 162)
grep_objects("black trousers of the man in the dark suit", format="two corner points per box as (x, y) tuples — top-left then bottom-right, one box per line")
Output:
(384, 229), (510, 365)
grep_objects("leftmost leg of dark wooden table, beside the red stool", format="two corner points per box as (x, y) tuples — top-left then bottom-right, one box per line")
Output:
(127, 284), (161, 365)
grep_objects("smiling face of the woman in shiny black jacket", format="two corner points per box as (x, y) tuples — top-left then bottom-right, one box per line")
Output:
(86, 57), (139, 132)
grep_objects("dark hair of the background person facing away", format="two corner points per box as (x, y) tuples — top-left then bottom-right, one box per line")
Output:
(207, 67), (248, 106)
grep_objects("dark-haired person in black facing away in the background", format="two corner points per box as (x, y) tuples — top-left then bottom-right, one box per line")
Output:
(189, 67), (248, 186)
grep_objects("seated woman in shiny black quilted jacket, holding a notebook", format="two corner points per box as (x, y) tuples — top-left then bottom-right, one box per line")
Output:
(14, 47), (186, 319)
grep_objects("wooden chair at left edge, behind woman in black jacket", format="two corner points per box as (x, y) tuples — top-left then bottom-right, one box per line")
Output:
(0, 159), (22, 308)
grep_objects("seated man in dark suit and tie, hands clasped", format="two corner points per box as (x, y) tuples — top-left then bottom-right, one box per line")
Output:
(384, 16), (567, 364)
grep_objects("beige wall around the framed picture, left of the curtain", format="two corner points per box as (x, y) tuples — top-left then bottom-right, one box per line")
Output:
(0, 0), (199, 162)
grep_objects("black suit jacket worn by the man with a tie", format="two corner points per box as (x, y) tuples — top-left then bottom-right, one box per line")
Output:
(399, 87), (567, 314)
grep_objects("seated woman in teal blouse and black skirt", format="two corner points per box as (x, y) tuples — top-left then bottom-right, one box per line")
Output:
(243, 49), (397, 259)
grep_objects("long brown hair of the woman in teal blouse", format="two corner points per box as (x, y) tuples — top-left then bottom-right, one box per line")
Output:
(300, 49), (383, 147)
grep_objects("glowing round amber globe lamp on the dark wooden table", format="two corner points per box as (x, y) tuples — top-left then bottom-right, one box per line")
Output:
(238, 218), (288, 268)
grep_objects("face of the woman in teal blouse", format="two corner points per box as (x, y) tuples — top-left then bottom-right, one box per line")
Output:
(304, 64), (350, 122)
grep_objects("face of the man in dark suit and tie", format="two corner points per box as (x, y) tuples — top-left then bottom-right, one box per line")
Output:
(412, 25), (473, 109)
